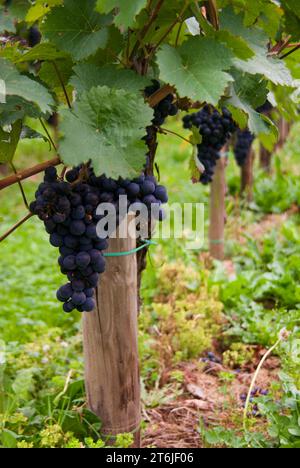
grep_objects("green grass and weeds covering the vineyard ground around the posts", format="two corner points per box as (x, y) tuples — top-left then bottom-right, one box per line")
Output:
(0, 121), (300, 448)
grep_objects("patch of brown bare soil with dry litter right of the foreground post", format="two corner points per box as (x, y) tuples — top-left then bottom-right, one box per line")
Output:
(143, 349), (280, 448)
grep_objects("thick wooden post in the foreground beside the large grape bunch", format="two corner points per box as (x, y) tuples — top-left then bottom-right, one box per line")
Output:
(83, 218), (141, 448)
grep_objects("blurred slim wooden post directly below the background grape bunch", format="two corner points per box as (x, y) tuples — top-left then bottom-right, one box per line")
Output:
(209, 157), (227, 260)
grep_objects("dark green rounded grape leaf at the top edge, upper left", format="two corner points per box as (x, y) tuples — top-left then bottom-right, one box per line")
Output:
(41, 0), (108, 60)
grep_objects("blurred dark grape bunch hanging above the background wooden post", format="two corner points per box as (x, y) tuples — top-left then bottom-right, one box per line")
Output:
(183, 106), (236, 184)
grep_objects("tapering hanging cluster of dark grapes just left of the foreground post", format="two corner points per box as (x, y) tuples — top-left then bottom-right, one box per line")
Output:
(30, 167), (108, 312)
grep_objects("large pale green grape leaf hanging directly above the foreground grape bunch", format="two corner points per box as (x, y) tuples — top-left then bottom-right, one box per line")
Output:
(59, 86), (153, 178)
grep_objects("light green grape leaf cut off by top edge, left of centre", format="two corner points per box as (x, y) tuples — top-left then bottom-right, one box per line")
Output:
(96, 0), (147, 28)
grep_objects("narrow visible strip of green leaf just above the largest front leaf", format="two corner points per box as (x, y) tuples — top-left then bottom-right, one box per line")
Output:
(70, 63), (149, 94)
